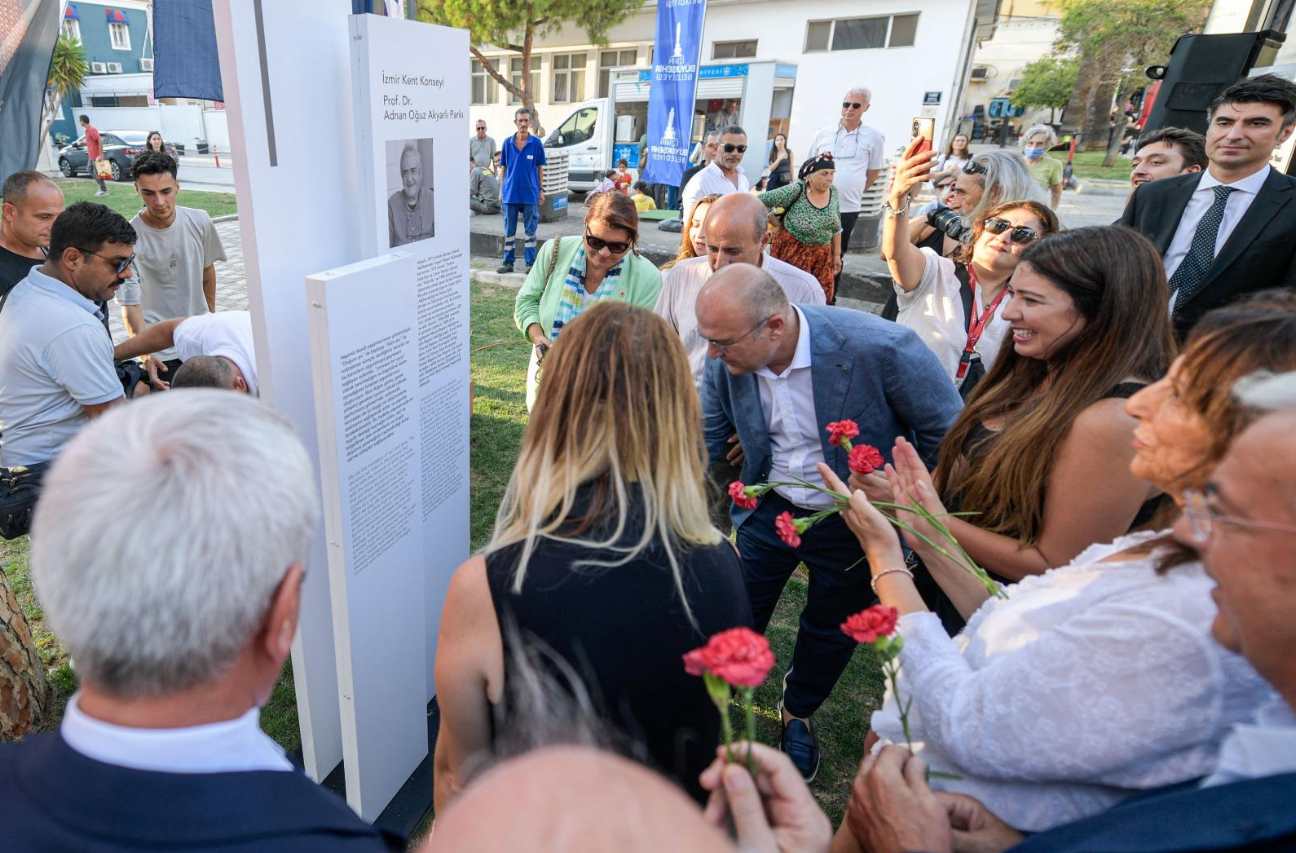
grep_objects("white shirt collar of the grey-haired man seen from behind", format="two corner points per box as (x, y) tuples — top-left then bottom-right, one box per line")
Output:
(58, 694), (293, 773)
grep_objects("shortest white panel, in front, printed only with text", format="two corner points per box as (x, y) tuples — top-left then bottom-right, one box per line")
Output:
(306, 253), (429, 821)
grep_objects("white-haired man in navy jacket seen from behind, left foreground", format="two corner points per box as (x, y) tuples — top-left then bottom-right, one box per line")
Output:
(0, 390), (403, 853)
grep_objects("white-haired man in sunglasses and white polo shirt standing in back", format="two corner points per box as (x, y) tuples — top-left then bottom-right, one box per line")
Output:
(806, 86), (886, 300)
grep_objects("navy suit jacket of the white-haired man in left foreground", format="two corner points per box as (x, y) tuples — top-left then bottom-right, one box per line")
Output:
(0, 732), (404, 853)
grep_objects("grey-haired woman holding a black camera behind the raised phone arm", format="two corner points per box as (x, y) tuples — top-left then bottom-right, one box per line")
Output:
(910, 152), (1045, 258)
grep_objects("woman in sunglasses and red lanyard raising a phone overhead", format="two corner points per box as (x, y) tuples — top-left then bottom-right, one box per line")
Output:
(883, 140), (1059, 398)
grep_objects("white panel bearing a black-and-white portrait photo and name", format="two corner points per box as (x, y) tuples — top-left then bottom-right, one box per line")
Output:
(350, 14), (470, 700)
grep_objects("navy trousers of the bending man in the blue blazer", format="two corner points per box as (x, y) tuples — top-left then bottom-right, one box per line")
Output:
(737, 491), (876, 717)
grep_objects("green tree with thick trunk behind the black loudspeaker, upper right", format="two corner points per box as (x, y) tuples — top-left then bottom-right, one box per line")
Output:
(1058, 0), (1210, 166)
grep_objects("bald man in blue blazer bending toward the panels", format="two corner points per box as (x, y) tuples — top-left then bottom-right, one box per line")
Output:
(696, 264), (962, 782)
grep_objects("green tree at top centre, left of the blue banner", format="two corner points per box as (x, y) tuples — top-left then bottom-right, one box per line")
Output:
(416, 0), (643, 134)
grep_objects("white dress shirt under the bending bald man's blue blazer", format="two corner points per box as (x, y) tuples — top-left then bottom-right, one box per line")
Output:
(756, 305), (832, 508)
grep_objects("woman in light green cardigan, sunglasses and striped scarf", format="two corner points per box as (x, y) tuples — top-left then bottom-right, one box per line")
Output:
(513, 193), (661, 411)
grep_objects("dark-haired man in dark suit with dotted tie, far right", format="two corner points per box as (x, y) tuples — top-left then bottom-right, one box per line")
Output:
(1120, 74), (1296, 340)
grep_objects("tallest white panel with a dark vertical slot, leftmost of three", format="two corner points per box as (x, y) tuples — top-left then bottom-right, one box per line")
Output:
(213, 0), (362, 782)
